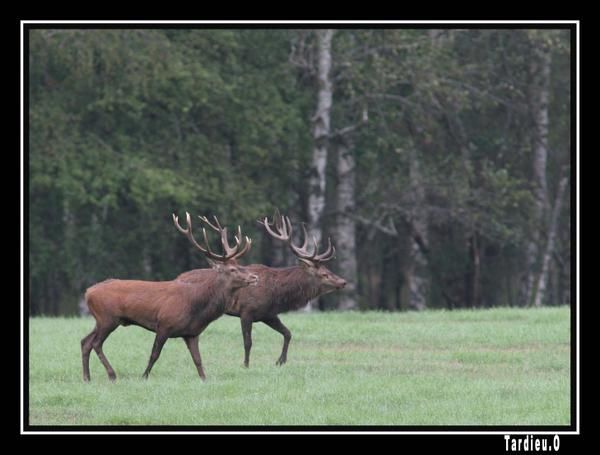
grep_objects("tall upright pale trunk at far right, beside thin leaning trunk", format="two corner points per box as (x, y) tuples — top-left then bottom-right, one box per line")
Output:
(525, 42), (551, 305)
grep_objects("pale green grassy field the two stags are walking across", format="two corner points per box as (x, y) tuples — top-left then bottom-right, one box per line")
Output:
(29, 307), (570, 425)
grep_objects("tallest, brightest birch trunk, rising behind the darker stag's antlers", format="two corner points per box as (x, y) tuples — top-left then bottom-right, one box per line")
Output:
(306, 30), (333, 311)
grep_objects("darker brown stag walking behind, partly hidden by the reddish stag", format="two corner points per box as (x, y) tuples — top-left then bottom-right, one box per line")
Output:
(177, 212), (346, 367)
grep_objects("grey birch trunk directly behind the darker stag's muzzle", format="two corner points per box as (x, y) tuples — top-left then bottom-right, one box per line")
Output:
(335, 140), (358, 310)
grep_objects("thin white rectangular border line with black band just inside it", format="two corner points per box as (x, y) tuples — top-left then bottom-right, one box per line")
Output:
(17, 19), (581, 438)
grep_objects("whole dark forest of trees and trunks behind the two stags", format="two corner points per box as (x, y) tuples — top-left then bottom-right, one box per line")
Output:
(25, 28), (573, 315)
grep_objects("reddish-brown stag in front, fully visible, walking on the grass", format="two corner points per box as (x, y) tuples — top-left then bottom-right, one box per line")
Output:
(81, 213), (258, 382)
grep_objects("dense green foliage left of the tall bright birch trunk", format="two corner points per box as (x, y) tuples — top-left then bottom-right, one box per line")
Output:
(29, 30), (309, 313)
